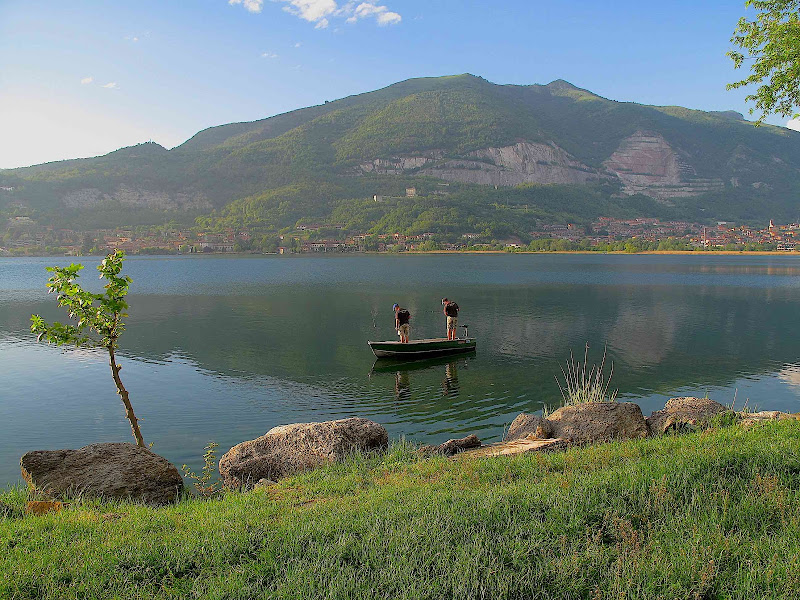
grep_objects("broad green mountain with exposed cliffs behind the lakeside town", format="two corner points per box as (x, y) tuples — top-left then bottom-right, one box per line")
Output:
(0, 75), (800, 231)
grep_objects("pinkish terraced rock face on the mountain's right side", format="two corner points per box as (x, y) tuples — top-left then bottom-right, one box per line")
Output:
(603, 131), (723, 200)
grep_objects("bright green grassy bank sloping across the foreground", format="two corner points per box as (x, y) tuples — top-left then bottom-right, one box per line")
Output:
(0, 421), (800, 599)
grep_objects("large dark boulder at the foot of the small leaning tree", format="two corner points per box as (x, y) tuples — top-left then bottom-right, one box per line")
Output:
(20, 443), (183, 505)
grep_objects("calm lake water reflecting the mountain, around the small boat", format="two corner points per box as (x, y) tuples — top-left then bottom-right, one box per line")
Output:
(0, 255), (800, 484)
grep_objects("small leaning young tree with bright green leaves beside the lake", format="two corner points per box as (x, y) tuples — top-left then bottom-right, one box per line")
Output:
(31, 250), (145, 446)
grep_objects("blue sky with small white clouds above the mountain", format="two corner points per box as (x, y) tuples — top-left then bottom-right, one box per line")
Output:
(0, 0), (786, 168)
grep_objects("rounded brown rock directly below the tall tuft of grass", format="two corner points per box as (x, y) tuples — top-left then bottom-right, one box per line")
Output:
(547, 402), (647, 444)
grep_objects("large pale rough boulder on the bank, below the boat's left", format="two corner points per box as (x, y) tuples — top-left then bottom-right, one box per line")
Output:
(219, 418), (389, 488)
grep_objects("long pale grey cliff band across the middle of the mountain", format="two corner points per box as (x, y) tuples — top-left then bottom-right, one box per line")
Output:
(359, 142), (609, 186)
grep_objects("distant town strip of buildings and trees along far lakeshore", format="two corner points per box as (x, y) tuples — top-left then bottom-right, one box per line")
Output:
(0, 216), (800, 256)
